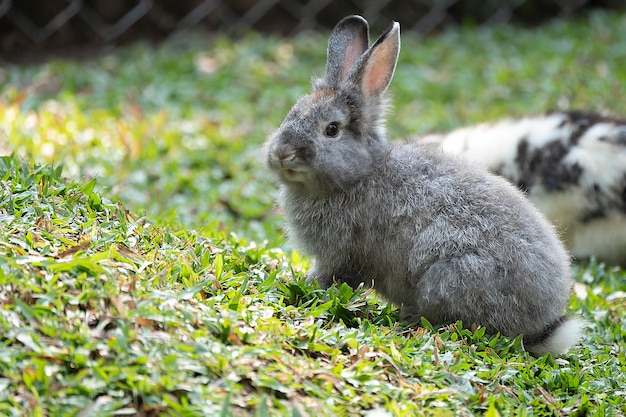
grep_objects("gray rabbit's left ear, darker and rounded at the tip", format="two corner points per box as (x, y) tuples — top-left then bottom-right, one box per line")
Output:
(326, 15), (369, 83)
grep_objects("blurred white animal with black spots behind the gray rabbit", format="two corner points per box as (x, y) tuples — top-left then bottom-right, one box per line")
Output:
(418, 111), (626, 266)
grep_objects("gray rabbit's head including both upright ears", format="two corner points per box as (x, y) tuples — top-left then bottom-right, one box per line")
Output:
(265, 16), (400, 193)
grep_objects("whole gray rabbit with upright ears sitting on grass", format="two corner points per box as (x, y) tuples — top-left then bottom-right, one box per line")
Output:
(265, 16), (583, 355)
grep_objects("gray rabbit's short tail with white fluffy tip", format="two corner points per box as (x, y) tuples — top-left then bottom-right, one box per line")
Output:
(524, 317), (585, 356)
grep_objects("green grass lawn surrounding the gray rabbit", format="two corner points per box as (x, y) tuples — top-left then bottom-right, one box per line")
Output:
(0, 9), (626, 417)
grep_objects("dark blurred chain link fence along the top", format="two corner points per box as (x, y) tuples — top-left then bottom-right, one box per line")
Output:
(0, 0), (626, 58)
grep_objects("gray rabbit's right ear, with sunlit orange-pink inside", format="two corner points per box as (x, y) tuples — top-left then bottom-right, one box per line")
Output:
(357, 22), (400, 97)
